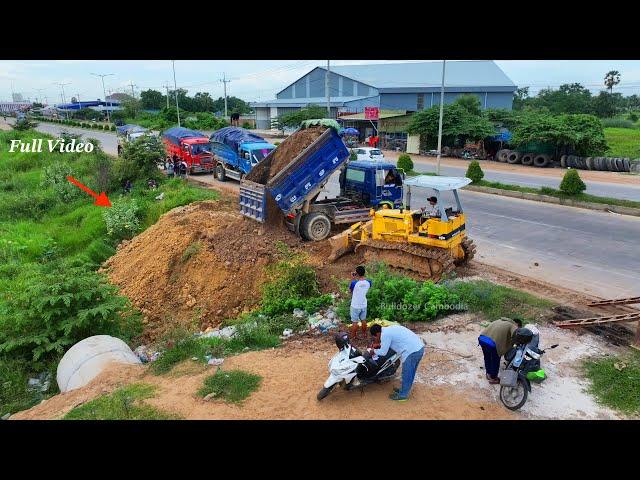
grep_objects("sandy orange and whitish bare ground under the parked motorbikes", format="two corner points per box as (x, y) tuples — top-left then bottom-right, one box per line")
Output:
(11, 314), (622, 420)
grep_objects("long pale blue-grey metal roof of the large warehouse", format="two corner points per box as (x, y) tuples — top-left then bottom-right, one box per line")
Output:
(331, 60), (516, 89)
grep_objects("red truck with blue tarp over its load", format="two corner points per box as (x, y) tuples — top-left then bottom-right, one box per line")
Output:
(162, 127), (214, 173)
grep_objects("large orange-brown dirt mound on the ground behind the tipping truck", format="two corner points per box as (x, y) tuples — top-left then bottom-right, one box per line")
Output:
(103, 201), (302, 340)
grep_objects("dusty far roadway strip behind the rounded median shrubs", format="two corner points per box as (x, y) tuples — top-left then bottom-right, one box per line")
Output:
(383, 150), (640, 185)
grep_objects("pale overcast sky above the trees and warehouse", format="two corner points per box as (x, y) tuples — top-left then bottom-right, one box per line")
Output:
(0, 60), (640, 103)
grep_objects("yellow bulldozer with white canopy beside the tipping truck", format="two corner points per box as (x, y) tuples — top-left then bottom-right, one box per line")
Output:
(329, 175), (476, 282)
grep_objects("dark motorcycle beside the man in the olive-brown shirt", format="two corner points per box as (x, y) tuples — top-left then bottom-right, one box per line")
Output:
(499, 328), (558, 411)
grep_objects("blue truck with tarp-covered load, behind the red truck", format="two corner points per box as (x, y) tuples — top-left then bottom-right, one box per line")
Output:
(209, 127), (276, 182)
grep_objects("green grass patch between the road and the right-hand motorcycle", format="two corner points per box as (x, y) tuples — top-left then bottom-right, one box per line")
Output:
(444, 280), (555, 323)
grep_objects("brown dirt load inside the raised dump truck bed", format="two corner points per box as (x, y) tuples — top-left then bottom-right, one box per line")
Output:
(245, 127), (327, 185)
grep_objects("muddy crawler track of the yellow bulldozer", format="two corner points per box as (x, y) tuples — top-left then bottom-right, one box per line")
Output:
(356, 240), (455, 282)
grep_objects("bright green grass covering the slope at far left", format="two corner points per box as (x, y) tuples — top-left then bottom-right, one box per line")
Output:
(0, 131), (219, 413)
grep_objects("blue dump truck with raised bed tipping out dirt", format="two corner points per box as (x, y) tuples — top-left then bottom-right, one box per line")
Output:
(240, 128), (404, 241)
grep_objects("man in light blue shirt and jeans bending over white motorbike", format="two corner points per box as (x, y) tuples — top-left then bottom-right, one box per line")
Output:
(369, 324), (424, 402)
